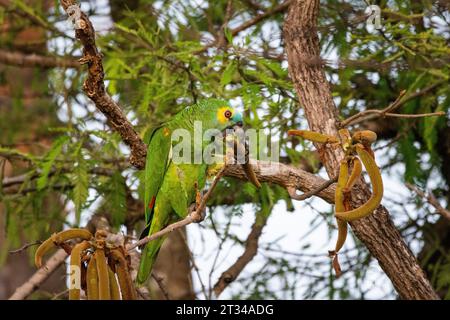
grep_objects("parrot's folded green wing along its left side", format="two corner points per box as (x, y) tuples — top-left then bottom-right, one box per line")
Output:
(144, 126), (172, 225)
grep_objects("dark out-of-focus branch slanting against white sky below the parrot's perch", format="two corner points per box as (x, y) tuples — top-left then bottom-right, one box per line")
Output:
(213, 215), (267, 298)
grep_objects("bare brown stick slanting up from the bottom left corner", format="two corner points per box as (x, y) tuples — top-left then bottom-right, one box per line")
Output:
(9, 249), (67, 300)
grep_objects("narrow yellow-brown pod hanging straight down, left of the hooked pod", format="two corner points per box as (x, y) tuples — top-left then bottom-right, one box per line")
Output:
(330, 160), (348, 255)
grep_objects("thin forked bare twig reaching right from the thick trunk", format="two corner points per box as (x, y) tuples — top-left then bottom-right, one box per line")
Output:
(339, 81), (445, 128)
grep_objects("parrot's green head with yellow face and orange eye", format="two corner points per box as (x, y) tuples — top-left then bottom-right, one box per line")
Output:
(197, 99), (243, 131)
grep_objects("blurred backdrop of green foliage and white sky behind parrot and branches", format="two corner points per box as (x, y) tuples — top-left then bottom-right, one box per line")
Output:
(0, 0), (450, 299)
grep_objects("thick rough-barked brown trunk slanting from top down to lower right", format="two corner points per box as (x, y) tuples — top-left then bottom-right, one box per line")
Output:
(283, 0), (438, 299)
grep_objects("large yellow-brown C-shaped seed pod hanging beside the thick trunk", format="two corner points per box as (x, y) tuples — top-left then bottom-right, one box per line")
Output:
(336, 144), (383, 221)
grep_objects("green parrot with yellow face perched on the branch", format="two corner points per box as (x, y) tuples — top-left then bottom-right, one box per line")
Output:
(136, 99), (242, 285)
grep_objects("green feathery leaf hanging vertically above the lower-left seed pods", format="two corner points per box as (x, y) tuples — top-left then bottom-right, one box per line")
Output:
(72, 149), (89, 225)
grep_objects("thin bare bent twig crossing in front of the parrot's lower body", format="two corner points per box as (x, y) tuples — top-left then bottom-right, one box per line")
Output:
(127, 166), (226, 251)
